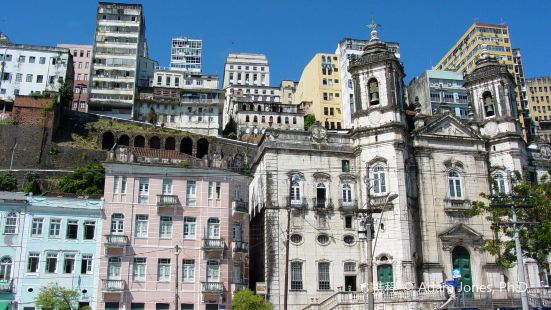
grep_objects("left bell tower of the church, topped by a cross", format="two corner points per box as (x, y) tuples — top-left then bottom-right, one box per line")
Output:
(349, 23), (406, 128)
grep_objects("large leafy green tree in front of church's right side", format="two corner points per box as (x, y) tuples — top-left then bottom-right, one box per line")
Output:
(470, 171), (551, 276)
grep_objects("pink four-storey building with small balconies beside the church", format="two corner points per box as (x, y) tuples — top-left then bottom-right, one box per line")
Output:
(97, 163), (249, 310)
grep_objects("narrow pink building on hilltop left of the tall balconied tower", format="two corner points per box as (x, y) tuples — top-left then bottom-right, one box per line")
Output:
(57, 44), (92, 112)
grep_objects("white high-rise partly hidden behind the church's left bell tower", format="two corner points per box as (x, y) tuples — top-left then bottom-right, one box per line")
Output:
(335, 38), (400, 128)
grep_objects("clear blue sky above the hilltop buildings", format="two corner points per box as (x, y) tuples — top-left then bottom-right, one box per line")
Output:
(0, 0), (551, 85)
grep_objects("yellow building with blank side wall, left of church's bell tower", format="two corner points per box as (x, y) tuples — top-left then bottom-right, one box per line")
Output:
(295, 53), (342, 129)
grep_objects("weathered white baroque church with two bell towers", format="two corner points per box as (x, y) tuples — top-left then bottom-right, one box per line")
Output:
(249, 30), (551, 309)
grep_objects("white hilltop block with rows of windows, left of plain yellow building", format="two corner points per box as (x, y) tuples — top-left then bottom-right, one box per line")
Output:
(222, 53), (270, 88)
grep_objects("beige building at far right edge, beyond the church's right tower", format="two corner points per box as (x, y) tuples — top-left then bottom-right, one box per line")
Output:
(526, 76), (551, 142)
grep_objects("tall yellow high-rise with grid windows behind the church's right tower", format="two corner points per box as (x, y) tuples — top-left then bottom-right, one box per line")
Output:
(434, 23), (530, 138)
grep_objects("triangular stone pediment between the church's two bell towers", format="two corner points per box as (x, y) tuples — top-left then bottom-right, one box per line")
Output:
(415, 113), (482, 139)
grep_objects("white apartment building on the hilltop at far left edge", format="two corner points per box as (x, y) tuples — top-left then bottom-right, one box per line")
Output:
(0, 42), (73, 101)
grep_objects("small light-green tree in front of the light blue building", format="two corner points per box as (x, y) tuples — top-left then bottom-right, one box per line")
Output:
(35, 283), (90, 310)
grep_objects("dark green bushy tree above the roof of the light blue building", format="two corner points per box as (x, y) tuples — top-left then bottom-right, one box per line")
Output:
(59, 163), (105, 194)
